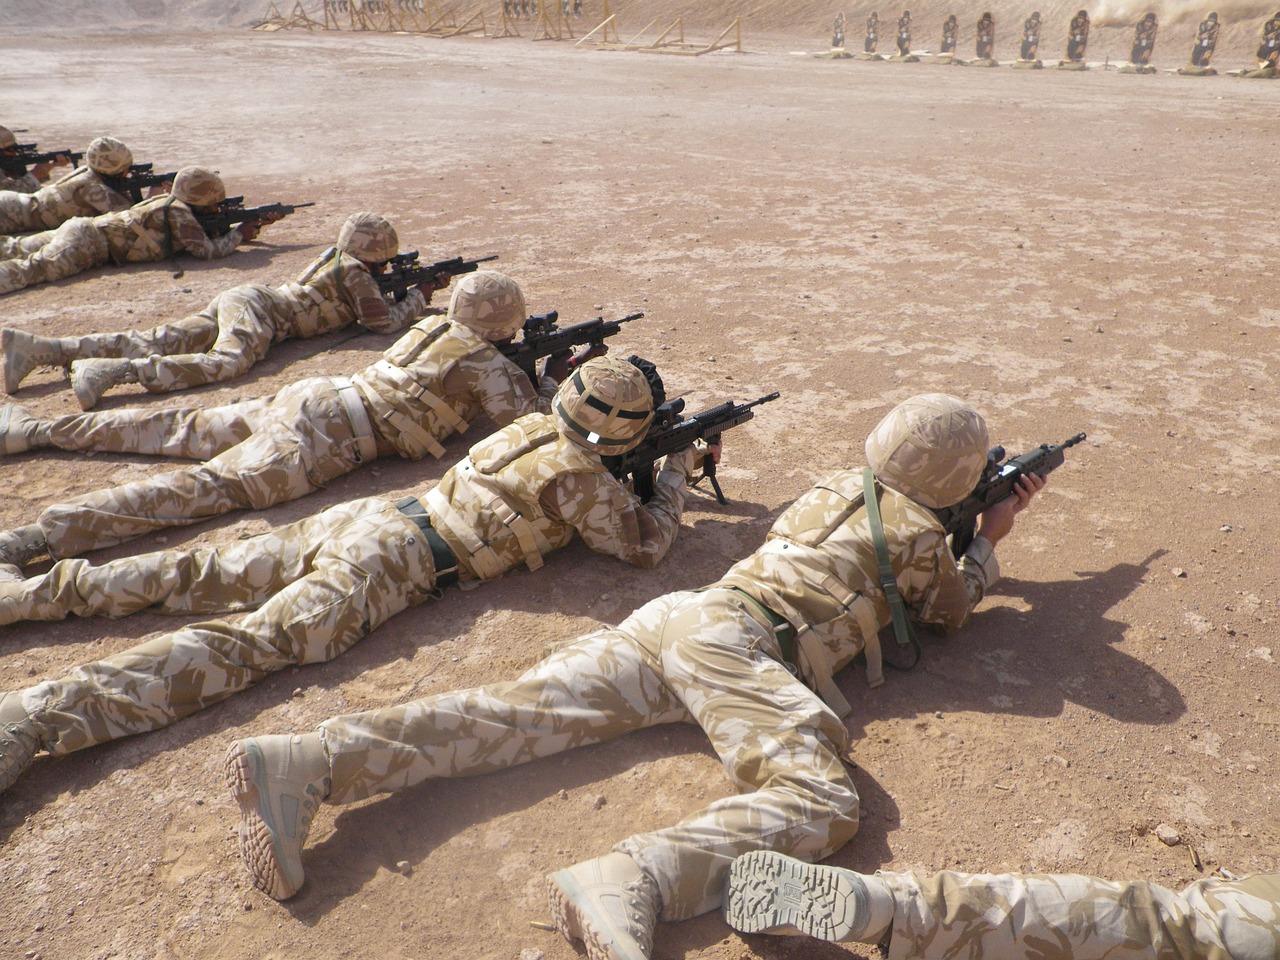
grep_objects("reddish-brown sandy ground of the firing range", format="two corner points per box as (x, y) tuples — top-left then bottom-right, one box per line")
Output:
(0, 26), (1280, 960)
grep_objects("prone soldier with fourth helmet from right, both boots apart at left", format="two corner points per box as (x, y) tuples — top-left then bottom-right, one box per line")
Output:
(0, 212), (449, 410)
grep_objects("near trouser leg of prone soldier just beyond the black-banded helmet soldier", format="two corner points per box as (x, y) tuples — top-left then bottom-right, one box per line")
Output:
(38, 380), (362, 559)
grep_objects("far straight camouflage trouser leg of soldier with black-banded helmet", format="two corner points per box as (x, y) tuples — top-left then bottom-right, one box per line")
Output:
(0, 499), (389, 625)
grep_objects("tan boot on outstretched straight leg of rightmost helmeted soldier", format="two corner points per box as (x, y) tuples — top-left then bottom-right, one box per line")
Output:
(224, 733), (332, 900)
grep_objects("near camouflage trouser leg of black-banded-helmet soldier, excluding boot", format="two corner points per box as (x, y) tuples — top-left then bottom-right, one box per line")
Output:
(22, 498), (435, 755)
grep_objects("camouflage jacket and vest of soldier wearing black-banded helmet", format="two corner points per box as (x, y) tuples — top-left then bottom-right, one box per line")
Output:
(422, 413), (692, 580)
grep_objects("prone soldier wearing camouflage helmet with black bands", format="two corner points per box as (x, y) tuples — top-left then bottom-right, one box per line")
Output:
(0, 357), (698, 790)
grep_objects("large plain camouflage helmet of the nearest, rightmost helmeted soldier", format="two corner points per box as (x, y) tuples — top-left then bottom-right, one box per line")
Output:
(867, 393), (987, 507)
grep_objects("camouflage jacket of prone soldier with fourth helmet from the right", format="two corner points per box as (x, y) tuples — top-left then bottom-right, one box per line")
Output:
(264, 247), (426, 340)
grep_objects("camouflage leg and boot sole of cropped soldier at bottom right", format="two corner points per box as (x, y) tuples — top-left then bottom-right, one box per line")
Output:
(724, 851), (1280, 960)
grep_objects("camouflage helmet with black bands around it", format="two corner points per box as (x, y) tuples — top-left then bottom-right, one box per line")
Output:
(554, 356), (653, 454)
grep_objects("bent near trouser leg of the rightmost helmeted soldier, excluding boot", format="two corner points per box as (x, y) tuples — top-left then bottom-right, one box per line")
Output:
(616, 590), (858, 920)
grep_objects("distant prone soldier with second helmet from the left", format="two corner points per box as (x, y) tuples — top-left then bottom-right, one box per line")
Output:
(0, 137), (133, 233)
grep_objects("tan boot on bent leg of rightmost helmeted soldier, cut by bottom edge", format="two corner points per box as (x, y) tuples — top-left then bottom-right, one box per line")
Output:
(547, 852), (662, 960)
